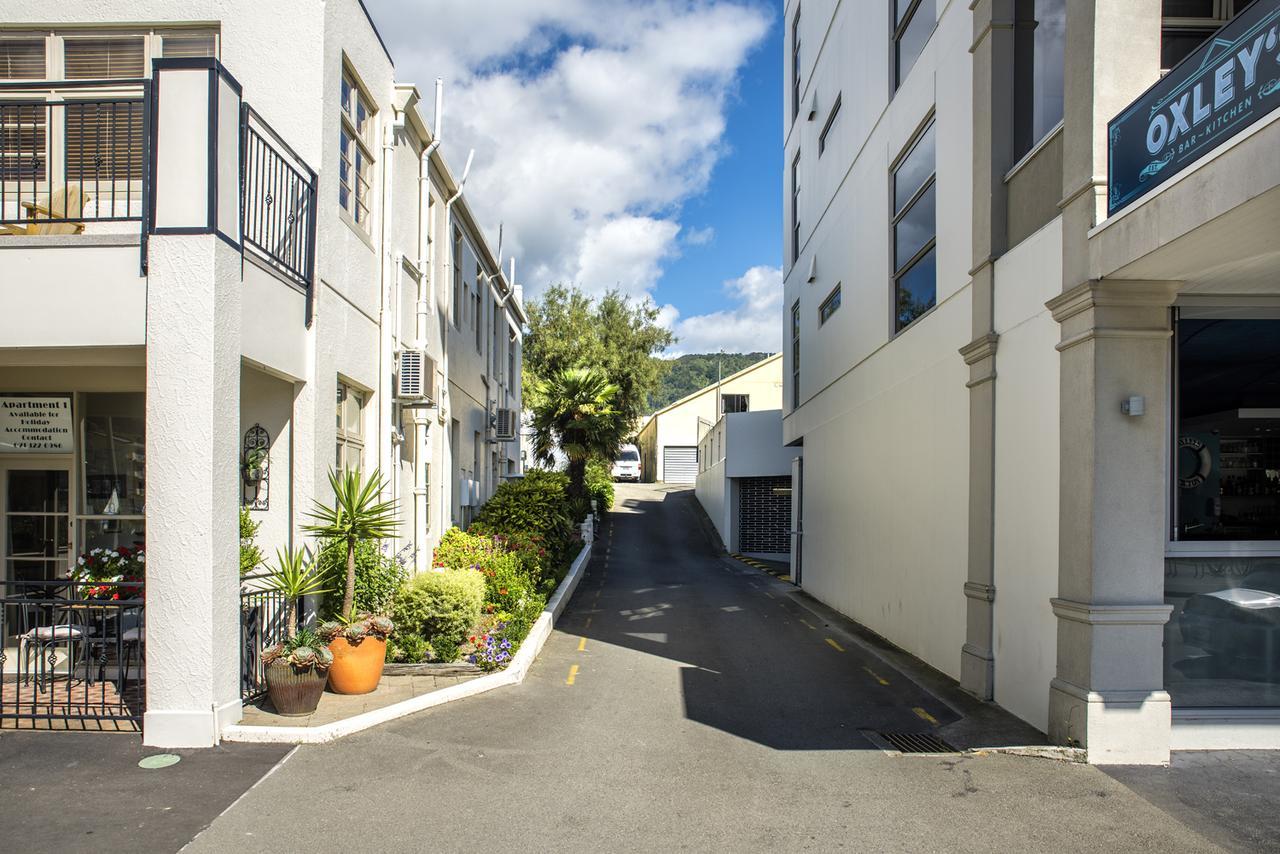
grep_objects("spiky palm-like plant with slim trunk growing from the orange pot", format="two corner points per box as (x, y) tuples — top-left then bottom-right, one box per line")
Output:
(302, 469), (399, 618)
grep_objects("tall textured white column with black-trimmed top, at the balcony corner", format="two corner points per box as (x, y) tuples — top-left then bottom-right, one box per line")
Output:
(142, 60), (242, 748)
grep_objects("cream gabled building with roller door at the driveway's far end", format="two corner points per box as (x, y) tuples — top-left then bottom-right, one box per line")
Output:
(636, 353), (782, 484)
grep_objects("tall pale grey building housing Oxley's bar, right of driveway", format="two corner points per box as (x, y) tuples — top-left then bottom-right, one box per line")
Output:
(783, 0), (1280, 762)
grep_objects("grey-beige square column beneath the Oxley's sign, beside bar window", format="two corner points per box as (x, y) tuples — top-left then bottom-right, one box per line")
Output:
(1048, 280), (1178, 764)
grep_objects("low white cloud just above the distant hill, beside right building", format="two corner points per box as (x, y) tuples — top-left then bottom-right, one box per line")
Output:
(659, 266), (782, 356)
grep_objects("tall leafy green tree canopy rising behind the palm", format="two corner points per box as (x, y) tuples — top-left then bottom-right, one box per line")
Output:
(524, 284), (676, 435)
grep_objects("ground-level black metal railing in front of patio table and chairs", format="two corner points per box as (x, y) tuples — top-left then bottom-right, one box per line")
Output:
(0, 580), (146, 730)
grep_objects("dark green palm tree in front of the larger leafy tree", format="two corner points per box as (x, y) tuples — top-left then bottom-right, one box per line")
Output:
(534, 367), (622, 502)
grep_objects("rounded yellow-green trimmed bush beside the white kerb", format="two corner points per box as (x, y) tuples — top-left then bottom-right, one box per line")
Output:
(392, 568), (485, 661)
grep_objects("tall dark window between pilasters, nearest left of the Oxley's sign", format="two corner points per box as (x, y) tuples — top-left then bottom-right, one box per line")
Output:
(1014, 0), (1066, 159)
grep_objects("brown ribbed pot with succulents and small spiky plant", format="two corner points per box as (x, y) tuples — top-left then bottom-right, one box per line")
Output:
(262, 549), (333, 717)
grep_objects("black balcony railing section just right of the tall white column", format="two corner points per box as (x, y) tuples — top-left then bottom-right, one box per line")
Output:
(241, 104), (316, 288)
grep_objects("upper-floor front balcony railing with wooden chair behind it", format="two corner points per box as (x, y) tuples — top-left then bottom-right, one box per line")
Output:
(0, 81), (151, 234)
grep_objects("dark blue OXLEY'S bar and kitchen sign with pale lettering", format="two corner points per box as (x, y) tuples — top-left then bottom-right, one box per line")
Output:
(1107, 0), (1280, 215)
